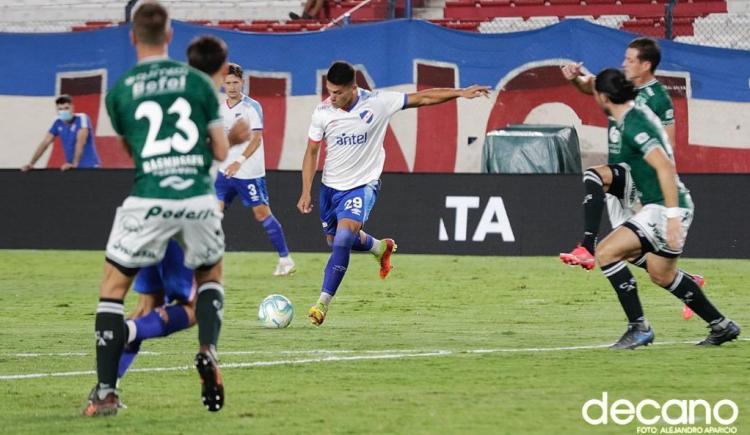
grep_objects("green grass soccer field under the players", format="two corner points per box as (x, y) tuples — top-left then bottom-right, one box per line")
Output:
(0, 251), (750, 434)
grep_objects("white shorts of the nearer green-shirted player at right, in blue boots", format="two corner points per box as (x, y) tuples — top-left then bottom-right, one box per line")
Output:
(624, 204), (693, 258)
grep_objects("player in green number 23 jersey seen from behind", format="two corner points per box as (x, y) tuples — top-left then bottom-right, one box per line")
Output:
(83, 1), (228, 416)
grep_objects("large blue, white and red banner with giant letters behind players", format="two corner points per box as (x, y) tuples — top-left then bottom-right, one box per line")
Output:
(0, 20), (750, 173)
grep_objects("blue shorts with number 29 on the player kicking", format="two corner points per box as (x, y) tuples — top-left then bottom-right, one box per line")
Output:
(320, 181), (380, 236)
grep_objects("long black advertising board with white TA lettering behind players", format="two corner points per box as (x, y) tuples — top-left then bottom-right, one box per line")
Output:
(0, 170), (750, 262)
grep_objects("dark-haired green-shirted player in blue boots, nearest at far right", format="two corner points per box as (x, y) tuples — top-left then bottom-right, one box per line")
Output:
(594, 68), (740, 349)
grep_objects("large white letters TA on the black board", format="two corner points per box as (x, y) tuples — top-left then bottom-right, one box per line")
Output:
(438, 196), (516, 242)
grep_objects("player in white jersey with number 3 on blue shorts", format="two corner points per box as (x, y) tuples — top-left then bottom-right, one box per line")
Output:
(214, 63), (295, 276)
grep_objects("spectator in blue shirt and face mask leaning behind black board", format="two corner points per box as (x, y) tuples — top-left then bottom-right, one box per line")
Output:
(21, 94), (99, 171)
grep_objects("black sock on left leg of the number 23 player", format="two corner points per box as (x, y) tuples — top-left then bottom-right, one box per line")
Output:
(94, 298), (128, 398)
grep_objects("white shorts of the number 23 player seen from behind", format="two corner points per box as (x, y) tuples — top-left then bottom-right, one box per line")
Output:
(107, 195), (224, 269)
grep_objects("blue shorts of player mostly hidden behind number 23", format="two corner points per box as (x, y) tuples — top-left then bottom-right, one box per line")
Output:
(133, 240), (193, 302)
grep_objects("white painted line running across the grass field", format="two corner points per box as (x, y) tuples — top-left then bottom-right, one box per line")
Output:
(0, 338), (750, 381)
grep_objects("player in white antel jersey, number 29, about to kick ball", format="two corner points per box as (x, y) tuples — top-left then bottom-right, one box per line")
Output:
(297, 61), (489, 325)
